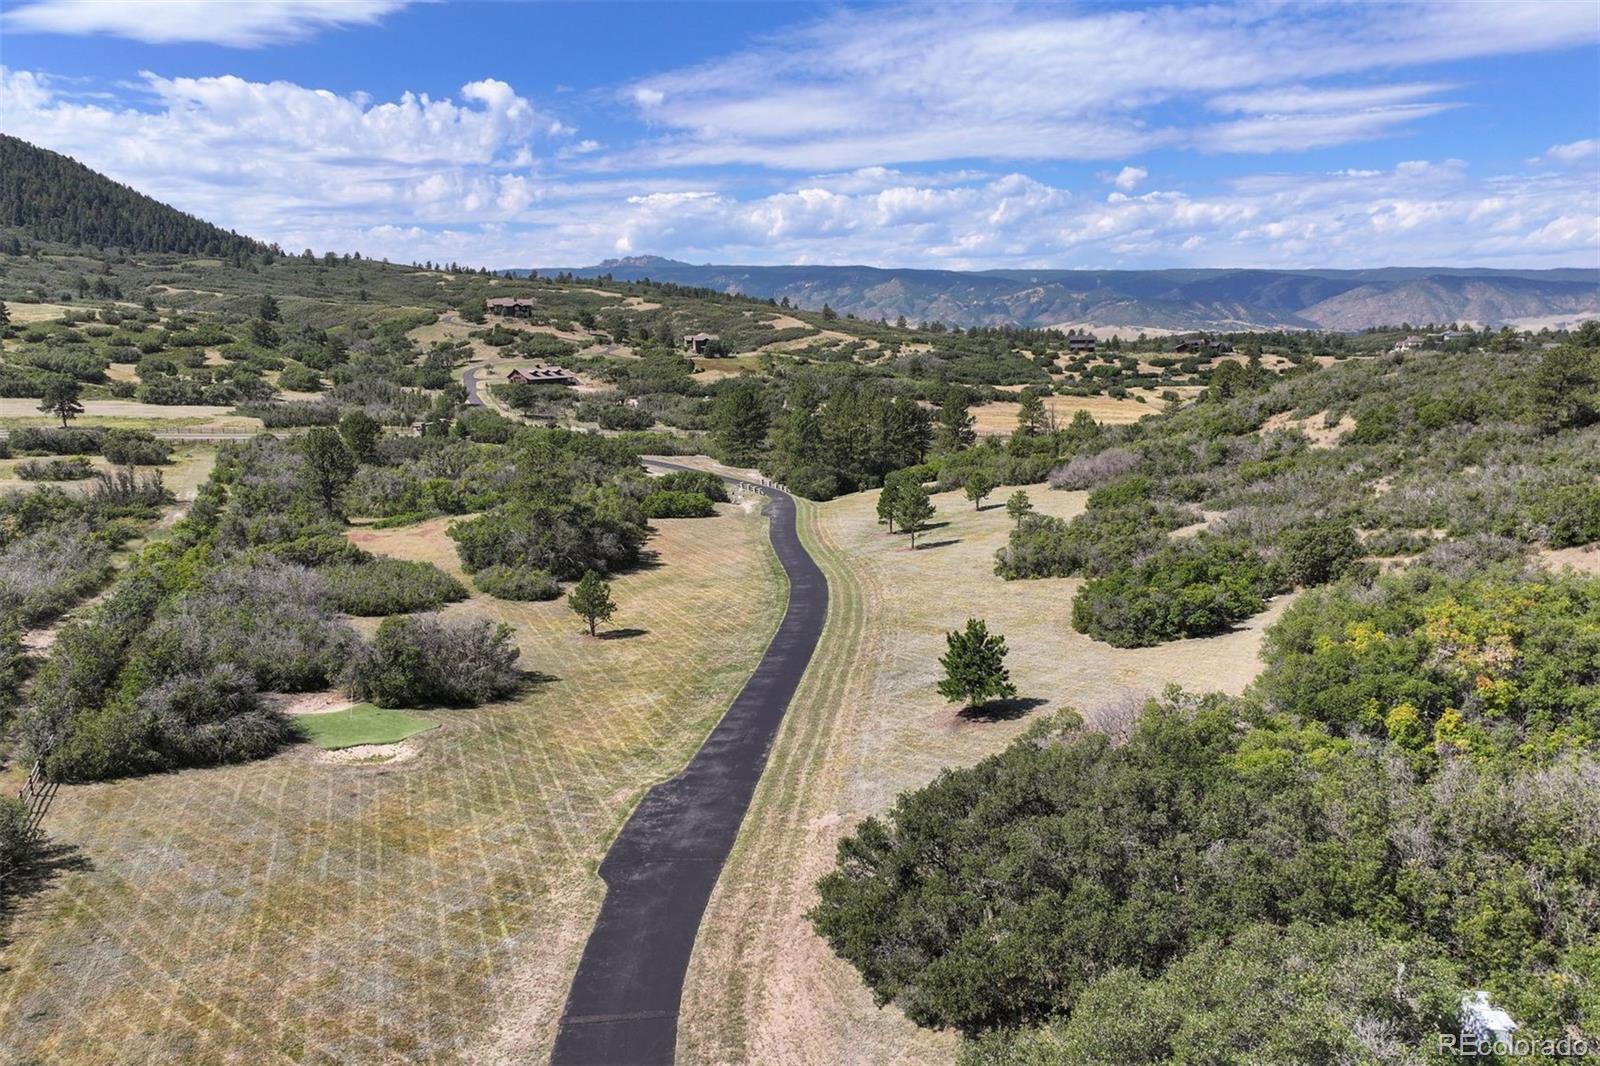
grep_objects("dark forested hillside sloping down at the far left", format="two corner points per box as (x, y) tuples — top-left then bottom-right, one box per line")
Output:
(0, 134), (262, 256)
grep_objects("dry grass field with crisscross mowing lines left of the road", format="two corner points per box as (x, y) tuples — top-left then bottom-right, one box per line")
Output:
(0, 506), (786, 1064)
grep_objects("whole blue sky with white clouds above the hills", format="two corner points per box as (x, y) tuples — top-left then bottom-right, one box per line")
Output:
(0, 0), (1600, 269)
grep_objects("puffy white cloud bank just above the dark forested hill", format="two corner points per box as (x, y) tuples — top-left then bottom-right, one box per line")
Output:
(0, 67), (563, 240)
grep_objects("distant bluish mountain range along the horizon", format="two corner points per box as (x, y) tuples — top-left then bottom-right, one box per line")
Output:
(539, 256), (1600, 333)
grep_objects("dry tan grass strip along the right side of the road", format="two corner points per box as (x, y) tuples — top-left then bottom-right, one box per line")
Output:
(678, 476), (1286, 1064)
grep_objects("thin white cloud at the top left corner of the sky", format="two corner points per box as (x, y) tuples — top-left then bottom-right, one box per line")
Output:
(3, 0), (410, 48)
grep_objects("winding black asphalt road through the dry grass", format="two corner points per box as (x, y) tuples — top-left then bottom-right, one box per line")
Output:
(550, 463), (827, 1066)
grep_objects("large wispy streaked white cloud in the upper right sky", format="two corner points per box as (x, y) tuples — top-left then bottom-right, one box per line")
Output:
(624, 0), (1600, 170)
